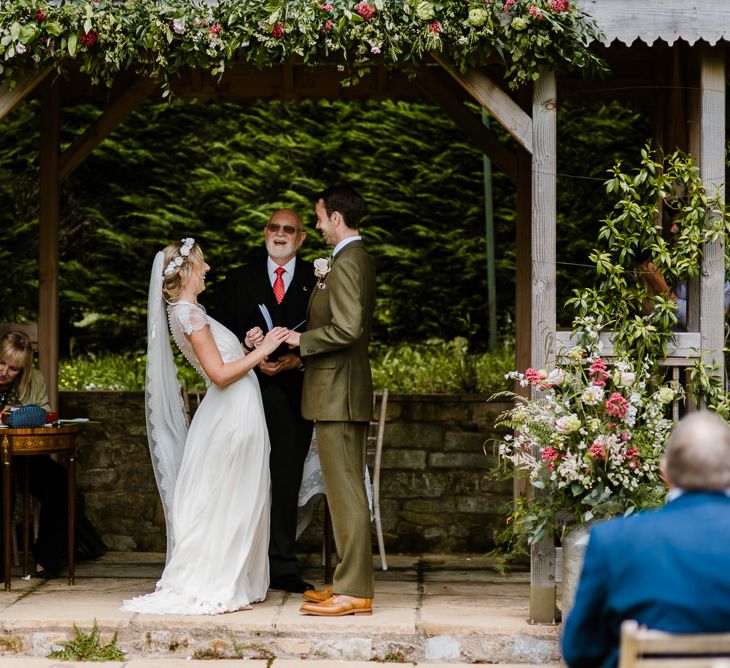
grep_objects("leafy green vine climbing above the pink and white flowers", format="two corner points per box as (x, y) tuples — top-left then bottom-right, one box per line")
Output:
(568, 144), (730, 363)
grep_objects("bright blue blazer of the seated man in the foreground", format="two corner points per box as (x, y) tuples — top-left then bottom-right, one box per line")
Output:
(562, 492), (730, 668)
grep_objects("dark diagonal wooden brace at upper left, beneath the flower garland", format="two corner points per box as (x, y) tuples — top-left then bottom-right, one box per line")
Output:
(58, 79), (158, 181)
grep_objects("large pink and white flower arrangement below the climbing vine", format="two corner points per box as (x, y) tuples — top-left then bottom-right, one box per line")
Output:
(497, 326), (683, 545)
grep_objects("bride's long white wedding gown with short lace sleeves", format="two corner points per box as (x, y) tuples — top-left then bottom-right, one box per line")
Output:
(122, 302), (270, 615)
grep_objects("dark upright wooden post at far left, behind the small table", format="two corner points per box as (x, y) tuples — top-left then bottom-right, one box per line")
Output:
(38, 79), (60, 410)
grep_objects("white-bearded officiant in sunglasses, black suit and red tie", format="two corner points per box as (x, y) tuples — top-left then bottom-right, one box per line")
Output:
(212, 209), (316, 593)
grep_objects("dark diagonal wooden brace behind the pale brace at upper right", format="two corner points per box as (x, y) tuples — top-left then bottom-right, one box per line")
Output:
(415, 65), (517, 184)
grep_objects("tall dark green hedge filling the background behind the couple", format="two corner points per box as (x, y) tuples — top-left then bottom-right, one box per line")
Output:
(0, 95), (646, 354)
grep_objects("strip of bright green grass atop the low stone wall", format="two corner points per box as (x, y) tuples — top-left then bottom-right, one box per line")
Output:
(58, 338), (514, 394)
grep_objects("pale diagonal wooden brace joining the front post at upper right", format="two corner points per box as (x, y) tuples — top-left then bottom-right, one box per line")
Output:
(431, 54), (533, 153)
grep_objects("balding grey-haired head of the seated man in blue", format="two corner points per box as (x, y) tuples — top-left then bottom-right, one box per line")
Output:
(663, 411), (730, 492)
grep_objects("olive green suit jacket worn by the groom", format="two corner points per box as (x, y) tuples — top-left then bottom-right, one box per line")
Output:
(300, 240), (375, 422)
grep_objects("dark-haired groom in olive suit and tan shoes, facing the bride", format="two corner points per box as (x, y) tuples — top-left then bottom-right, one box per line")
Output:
(287, 185), (375, 616)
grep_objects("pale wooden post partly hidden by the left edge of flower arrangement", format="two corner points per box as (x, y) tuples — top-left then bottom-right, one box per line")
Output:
(530, 70), (557, 624)
